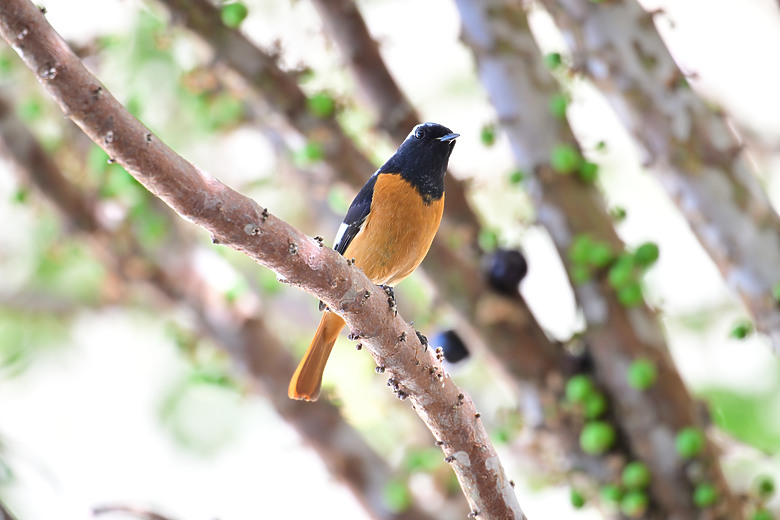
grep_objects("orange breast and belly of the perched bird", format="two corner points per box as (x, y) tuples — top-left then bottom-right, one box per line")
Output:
(344, 173), (444, 286)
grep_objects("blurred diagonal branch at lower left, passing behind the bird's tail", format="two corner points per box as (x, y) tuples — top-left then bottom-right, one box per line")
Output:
(0, 93), (450, 520)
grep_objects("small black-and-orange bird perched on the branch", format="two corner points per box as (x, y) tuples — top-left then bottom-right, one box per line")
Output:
(287, 123), (459, 401)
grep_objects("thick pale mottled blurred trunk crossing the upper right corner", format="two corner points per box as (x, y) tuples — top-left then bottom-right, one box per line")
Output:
(542, 0), (780, 353)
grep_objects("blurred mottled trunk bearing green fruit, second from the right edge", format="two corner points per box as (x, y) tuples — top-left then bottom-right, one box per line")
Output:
(456, 0), (743, 520)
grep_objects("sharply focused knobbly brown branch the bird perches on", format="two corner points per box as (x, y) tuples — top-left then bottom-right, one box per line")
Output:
(0, 0), (525, 519)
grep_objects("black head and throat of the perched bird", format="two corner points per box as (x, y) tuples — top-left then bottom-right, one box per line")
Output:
(379, 123), (459, 200)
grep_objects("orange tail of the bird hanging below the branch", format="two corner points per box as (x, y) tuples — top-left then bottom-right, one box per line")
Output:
(287, 312), (345, 401)
